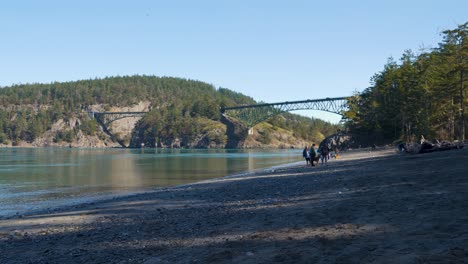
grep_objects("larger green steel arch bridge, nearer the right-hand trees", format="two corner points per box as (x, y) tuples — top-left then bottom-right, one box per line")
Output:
(221, 97), (348, 128)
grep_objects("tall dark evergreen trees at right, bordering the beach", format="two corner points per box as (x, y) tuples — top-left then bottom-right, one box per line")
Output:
(346, 22), (468, 145)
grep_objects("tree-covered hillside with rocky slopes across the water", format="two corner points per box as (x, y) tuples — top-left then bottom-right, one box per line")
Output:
(0, 76), (337, 147)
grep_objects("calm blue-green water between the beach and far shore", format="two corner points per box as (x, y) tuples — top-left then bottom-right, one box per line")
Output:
(0, 148), (302, 216)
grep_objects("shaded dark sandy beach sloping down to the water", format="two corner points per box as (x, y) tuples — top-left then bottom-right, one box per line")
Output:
(0, 148), (468, 264)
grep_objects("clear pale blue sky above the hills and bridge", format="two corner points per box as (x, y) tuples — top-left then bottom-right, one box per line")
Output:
(0, 0), (468, 123)
